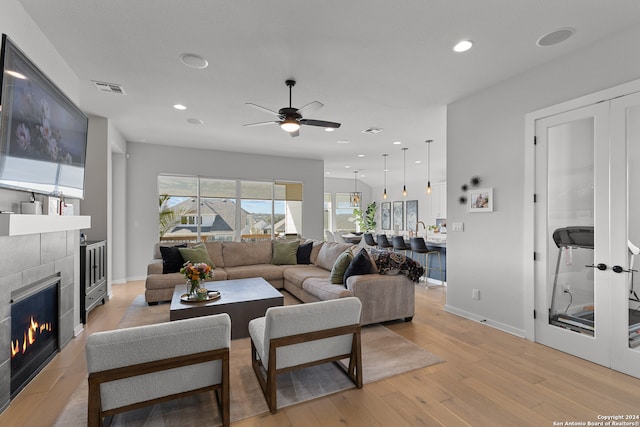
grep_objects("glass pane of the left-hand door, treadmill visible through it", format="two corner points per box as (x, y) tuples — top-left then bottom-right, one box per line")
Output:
(547, 118), (596, 336)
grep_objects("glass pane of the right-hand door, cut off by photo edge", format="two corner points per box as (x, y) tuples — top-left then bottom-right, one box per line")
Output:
(626, 106), (640, 351)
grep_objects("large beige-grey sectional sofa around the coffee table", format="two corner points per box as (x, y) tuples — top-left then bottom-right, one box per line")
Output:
(145, 240), (415, 325)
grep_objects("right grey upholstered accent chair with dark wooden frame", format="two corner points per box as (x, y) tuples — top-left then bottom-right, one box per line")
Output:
(249, 297), (362, 414)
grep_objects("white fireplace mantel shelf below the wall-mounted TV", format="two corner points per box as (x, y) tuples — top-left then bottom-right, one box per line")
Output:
(0, 213), (91, 236)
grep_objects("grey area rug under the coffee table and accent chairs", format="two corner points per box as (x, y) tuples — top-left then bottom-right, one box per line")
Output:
(55, 295), (443, 427)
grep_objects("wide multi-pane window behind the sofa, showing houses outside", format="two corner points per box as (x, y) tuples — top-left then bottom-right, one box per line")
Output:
(158, 175), (302, 241)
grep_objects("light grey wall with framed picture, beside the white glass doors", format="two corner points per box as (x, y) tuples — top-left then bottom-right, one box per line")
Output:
(446, 27), (640, 335)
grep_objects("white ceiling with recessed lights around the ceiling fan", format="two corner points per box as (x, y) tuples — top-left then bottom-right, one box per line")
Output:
(20, 0), (640, 185)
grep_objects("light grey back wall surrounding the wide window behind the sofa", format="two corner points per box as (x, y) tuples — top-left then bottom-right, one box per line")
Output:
(126, 142), (324, 280)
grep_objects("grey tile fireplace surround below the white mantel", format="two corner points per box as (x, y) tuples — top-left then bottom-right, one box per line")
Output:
(0, 230), (79, 412)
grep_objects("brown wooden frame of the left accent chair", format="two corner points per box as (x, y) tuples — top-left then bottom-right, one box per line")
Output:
(87, 347), (231, 427)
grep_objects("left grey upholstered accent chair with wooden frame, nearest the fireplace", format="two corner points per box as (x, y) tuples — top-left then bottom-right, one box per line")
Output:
(86, 313), (231, 427)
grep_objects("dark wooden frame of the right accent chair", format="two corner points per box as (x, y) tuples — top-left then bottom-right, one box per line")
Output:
(251, 324), (362, 414)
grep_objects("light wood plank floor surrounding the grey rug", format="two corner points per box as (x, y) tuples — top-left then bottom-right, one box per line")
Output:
(0, 282), (640, 427)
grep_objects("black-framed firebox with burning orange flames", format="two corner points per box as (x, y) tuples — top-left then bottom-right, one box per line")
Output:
(11, 276), (60, 398)
